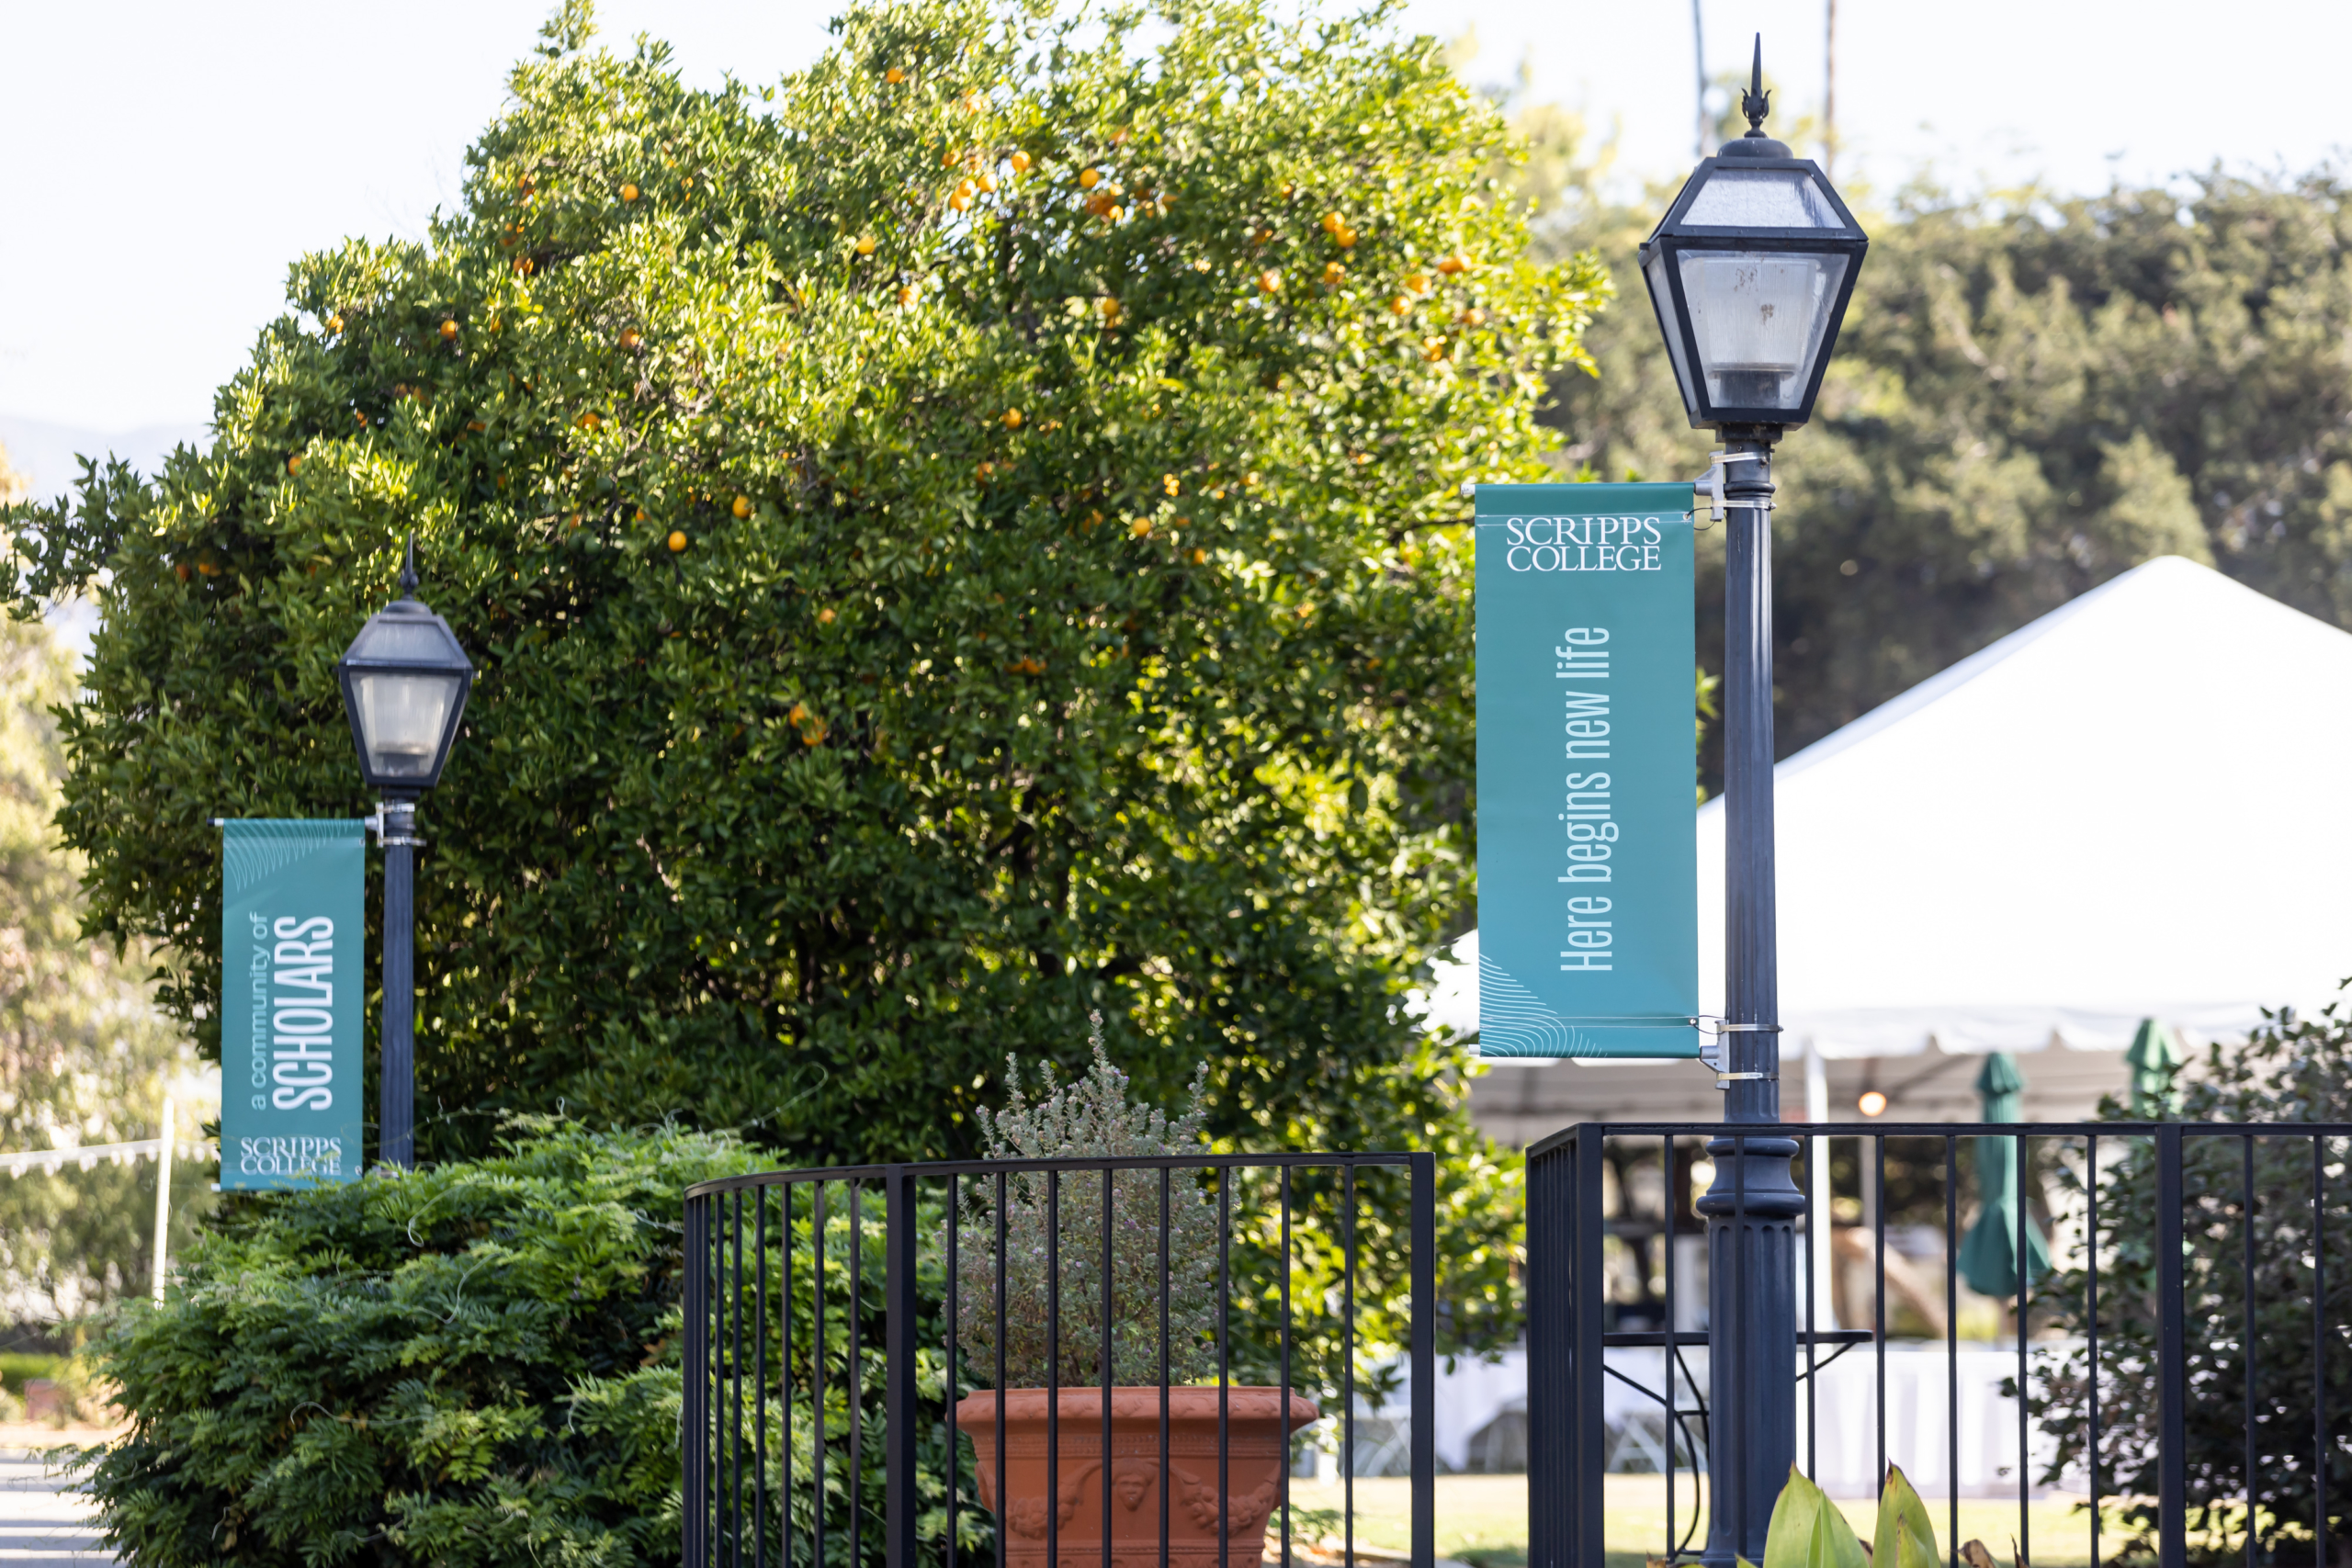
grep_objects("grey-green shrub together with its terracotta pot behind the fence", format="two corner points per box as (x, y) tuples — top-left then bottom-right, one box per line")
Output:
(955, 1018), (1319, 1568)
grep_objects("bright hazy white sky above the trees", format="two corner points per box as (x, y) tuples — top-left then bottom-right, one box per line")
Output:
(0, 0), (2352, 433)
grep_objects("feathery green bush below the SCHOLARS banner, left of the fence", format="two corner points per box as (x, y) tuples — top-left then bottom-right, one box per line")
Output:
(89, 1119), (762, 1568)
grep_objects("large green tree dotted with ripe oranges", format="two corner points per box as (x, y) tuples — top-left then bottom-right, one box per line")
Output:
(9, 0), (1606, 1222)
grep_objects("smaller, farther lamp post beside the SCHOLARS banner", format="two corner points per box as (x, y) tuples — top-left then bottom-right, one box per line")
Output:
(334, 536), (473, 1168)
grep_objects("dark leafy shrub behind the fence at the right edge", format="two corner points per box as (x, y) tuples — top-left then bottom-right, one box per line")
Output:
(2032, 1001), (2352, 1565)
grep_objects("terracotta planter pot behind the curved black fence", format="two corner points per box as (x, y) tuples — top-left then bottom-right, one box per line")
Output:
(955, 1387), (1319, 1568)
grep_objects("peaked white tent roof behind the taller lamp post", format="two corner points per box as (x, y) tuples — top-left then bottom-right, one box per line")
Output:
(1432, 558), (2352, 1058)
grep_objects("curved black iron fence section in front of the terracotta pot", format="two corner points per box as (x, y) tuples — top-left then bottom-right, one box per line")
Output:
(682, 1155), (1437, 1568)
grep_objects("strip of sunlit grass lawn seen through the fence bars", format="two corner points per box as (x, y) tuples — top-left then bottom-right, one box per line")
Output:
(1291, 1476), (2121, 1568)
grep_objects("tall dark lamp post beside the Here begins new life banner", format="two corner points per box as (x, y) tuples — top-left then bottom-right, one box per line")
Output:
(1642, 40), (1868, 1568)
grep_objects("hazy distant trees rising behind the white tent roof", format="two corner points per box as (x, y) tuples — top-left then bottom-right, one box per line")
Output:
(1543, 172), (2352, 780)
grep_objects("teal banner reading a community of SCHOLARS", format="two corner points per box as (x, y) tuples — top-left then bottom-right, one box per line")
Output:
(221, 820), (367, 1190)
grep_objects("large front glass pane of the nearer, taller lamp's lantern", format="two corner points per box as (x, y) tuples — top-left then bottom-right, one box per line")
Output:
(1681, 252), (1847, 412)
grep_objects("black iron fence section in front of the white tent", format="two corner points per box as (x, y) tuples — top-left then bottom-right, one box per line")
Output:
(1526, 1123), (2352, 1568)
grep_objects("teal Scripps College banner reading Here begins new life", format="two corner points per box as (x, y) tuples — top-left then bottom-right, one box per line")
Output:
(1477, 484), (1701, 1055)
